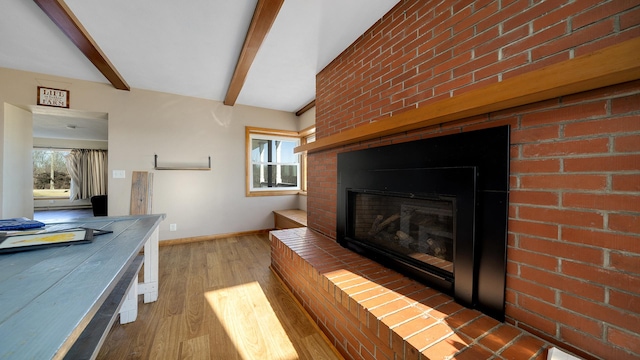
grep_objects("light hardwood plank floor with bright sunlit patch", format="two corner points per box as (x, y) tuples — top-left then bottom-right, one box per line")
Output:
(98, 234), (340, 360)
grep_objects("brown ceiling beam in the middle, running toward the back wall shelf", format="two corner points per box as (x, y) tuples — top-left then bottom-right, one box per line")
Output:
(224, 0), (284, 106)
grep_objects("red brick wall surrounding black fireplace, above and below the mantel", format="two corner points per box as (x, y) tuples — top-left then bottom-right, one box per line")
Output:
(308, 0), (640, 358)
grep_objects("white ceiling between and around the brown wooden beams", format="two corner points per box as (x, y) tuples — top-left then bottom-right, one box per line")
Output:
(0, 0), (398, 112)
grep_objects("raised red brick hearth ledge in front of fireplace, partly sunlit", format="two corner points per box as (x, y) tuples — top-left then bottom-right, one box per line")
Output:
(270, 228), (551, 359)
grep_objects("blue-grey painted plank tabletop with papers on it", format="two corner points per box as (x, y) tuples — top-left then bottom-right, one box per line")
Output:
(0, 215), (164, 359)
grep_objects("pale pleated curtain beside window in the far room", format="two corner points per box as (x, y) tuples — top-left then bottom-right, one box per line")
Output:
(65, 149), (107, 200)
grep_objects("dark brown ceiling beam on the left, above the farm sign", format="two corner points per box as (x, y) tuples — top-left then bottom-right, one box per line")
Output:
(33, 0), (129, 90)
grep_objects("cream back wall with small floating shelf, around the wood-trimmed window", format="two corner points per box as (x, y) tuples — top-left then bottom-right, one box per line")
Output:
(0, 68), (298, 240)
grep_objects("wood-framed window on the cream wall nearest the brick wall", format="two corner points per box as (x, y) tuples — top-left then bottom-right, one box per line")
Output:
(246, 127), (301, 196)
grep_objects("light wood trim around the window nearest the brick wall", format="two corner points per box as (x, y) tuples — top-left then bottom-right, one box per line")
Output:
(245, 126), (303, 197)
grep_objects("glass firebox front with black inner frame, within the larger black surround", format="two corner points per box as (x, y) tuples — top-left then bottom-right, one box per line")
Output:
(339, 167), (476, 303)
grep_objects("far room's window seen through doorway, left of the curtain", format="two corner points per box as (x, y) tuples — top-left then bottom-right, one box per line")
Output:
(32, 149), (71, 198)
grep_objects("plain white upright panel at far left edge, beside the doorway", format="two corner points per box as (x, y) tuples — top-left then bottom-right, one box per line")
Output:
(0, 104), (33, 218)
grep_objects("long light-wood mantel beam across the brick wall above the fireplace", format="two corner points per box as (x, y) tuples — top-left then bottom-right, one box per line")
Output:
(294, 37), (640, 153)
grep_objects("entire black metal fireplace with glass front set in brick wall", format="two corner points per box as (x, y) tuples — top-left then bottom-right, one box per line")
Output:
(337, 126), (509, 321)
